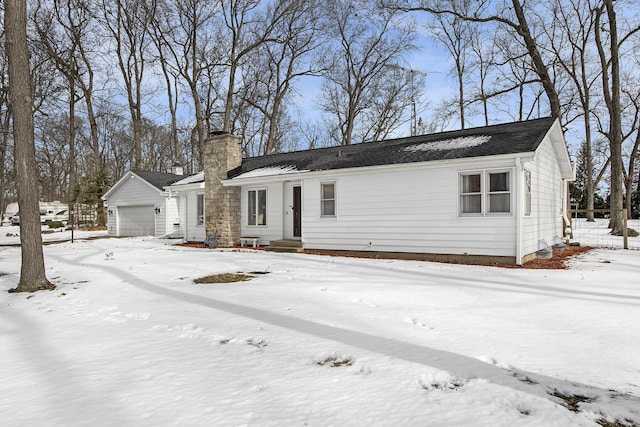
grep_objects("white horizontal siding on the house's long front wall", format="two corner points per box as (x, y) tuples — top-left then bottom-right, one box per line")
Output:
(302, 160), (515, 256)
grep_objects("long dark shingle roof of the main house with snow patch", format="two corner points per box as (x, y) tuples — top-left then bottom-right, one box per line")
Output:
(228, 118), (555, 178)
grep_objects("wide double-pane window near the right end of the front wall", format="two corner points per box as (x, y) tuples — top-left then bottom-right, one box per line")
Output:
(460, 171), (511, 215)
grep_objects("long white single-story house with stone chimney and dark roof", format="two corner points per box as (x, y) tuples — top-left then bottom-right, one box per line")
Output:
(205, 118), (574, 264)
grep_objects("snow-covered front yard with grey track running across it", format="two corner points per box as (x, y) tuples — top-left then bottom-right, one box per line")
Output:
(0, 234), (640, 426)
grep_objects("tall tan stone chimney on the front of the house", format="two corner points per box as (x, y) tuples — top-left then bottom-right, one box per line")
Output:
(203, 133), (242, 247)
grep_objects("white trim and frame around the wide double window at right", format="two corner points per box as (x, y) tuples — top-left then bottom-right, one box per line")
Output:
(458, 168), (514, 218)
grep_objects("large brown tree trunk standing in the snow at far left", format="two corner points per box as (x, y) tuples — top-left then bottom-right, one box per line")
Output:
(4, 0), (55, 292)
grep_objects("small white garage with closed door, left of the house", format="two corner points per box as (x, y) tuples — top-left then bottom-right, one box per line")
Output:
(102, 170), (184, 237)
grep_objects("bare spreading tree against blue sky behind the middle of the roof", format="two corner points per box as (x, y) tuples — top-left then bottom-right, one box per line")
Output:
(320, 0), (415, 145)
